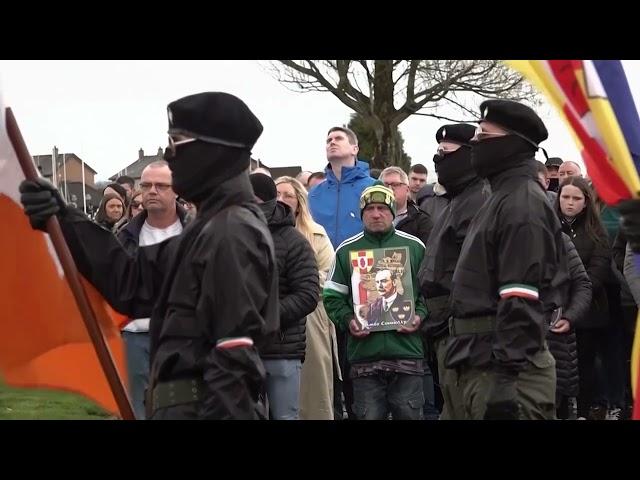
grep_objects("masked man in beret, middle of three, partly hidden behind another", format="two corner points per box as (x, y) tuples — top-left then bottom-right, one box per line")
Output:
(418, 124), (489, 420)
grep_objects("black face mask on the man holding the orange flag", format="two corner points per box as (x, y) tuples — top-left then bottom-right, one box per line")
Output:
(164, 141), (249, 203)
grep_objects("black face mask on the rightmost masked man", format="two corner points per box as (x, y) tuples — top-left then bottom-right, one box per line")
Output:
(471, 135), (535, 178)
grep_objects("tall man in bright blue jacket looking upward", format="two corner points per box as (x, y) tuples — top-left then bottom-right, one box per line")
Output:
(309, 127), (375, 419)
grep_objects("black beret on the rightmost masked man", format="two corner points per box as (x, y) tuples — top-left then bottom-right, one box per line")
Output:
(480, 100), (549, 146)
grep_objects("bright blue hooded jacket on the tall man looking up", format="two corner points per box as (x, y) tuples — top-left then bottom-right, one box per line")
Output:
(309, 161), (375, 249)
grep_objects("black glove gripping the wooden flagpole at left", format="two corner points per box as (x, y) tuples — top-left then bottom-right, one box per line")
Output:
(20, 178), (67, 231)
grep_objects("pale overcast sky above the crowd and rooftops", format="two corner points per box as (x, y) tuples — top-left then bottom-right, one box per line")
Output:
(0, 60), (640, 179)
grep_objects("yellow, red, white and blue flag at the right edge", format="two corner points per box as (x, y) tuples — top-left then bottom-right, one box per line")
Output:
(506, 60), (640, 420)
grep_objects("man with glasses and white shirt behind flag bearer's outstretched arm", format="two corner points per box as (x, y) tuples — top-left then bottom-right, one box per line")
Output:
(118, 160), (187, 419)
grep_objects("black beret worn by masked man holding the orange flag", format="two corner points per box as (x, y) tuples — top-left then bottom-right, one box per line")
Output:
(167, 92), (263, 151)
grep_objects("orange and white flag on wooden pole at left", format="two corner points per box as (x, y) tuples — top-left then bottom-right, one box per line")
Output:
(0, 93), (126, 414)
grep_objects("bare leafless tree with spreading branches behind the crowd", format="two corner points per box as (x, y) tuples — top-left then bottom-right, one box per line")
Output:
(271, 60), (537, 168)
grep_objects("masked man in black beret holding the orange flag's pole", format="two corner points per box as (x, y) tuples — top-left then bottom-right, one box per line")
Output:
(20, 92), (279, 419)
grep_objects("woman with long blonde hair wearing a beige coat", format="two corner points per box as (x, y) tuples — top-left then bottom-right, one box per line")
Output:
(276, 177), (340, 420)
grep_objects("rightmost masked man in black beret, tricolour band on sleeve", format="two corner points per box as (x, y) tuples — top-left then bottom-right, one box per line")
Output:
(445, 100), (568, 419)
